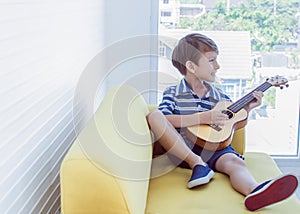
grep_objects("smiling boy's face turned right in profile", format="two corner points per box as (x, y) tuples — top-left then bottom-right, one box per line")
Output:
(188, 51), (220, 82)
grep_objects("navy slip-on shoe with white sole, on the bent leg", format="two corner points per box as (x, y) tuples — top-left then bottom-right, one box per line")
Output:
(188, 165), (215, 188)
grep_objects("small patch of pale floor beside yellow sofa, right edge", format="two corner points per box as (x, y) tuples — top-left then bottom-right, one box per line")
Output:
(275, 159), (300, 201)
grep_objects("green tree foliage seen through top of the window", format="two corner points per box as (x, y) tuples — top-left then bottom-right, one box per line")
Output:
(180, 0), (300, 51)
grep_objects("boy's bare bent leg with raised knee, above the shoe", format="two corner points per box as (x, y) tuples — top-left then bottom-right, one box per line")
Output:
(147, 110), (205, 169)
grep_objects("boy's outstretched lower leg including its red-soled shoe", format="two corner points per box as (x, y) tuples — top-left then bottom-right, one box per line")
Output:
(216, 153), (298, 211)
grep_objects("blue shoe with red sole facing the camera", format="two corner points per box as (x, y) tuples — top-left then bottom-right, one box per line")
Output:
(244, 174), (298, 211)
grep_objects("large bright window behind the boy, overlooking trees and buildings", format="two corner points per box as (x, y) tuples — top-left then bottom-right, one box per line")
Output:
(158, 0), (300, 157)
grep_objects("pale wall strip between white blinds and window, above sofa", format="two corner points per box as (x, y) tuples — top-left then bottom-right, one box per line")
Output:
(101, 0), (158, 103)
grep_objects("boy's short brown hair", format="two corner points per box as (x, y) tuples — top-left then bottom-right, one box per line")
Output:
(172, 33), (219, 75)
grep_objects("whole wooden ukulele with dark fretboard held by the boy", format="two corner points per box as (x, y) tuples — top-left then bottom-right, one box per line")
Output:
(185, 75), (288, 151)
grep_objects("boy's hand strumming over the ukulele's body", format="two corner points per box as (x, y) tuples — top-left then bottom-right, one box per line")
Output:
(200, 110), (228, 125)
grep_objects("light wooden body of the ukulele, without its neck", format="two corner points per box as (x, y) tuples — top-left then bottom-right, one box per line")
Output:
(185, 101), (248, 151)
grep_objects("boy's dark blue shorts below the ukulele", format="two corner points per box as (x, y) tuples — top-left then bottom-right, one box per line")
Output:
(168, 145), (244, 171)
